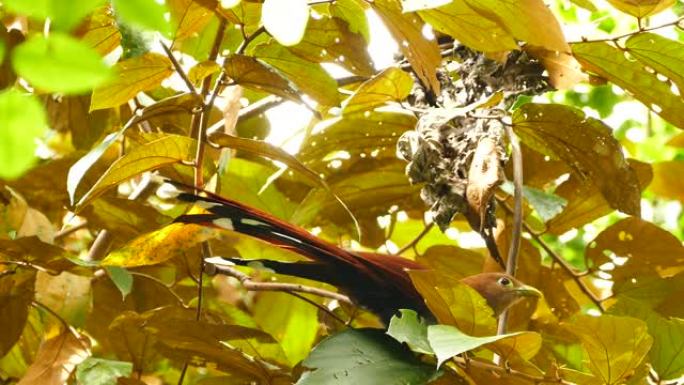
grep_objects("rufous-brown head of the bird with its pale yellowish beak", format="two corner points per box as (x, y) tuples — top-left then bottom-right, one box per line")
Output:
(461, 273), (542, 316)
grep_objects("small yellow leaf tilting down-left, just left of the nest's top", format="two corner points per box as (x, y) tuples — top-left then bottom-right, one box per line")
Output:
(342, 67), (413, 114)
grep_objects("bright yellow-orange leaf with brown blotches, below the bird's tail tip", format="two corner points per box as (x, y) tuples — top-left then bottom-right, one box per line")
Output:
(102, 223), (215, 267)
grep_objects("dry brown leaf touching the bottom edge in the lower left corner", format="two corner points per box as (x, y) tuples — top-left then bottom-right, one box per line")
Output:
(17, 329), (90, 385)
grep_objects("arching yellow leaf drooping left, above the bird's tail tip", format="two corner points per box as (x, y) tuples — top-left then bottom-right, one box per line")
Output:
(78, 135), (196, 207)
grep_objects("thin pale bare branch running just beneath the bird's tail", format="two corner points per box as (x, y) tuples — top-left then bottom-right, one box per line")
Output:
(206, 263), (354, 305)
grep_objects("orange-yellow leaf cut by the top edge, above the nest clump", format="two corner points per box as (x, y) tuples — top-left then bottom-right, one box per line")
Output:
(466, 0), (568, 52)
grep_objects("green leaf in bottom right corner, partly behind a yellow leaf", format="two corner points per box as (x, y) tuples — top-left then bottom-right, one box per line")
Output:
(610, 298), (684, 381)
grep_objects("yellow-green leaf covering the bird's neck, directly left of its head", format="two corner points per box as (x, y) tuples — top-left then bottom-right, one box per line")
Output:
(409, 270), (496, 336)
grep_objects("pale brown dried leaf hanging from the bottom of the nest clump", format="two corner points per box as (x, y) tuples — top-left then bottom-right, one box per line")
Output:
(466, 138), (504, 232)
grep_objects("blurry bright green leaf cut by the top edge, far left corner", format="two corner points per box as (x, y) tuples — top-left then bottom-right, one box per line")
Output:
(4, 0), (104, 31)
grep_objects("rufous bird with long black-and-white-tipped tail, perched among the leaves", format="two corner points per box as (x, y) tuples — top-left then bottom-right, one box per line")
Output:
(169, 182), (541, 324)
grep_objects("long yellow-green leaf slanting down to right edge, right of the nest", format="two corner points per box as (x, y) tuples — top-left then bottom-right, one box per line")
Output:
(572, 42), (684, 129)
